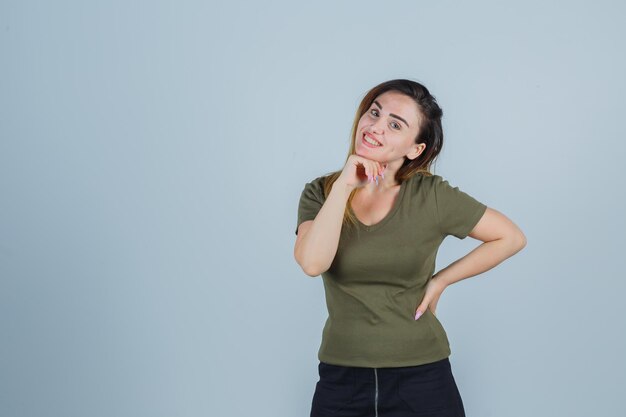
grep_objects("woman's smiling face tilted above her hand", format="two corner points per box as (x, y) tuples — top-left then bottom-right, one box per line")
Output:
(355, 91), (426, 165)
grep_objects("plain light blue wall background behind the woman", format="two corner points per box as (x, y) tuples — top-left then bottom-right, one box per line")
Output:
(0, 0), (626, 417)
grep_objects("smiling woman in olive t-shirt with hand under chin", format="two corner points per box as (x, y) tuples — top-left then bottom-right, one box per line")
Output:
(294, 79), (526, 417)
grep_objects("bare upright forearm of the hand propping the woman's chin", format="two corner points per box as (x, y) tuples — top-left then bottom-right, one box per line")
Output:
(296, 182), (351, 276)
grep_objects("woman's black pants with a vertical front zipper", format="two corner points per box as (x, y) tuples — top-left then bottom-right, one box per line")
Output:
(311, 358), (465, 417)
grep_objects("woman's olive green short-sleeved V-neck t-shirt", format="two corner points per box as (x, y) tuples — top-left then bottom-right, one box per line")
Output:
(296, 174), (487, 367)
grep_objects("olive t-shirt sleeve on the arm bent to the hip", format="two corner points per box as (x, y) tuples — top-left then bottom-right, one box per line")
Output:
(433, 175), (487, 239)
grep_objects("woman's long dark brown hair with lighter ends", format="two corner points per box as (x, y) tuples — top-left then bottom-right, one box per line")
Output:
(324, 79), (443, 225)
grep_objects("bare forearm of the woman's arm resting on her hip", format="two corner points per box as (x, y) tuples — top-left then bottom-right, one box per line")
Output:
(434, 238), (525, 286)
